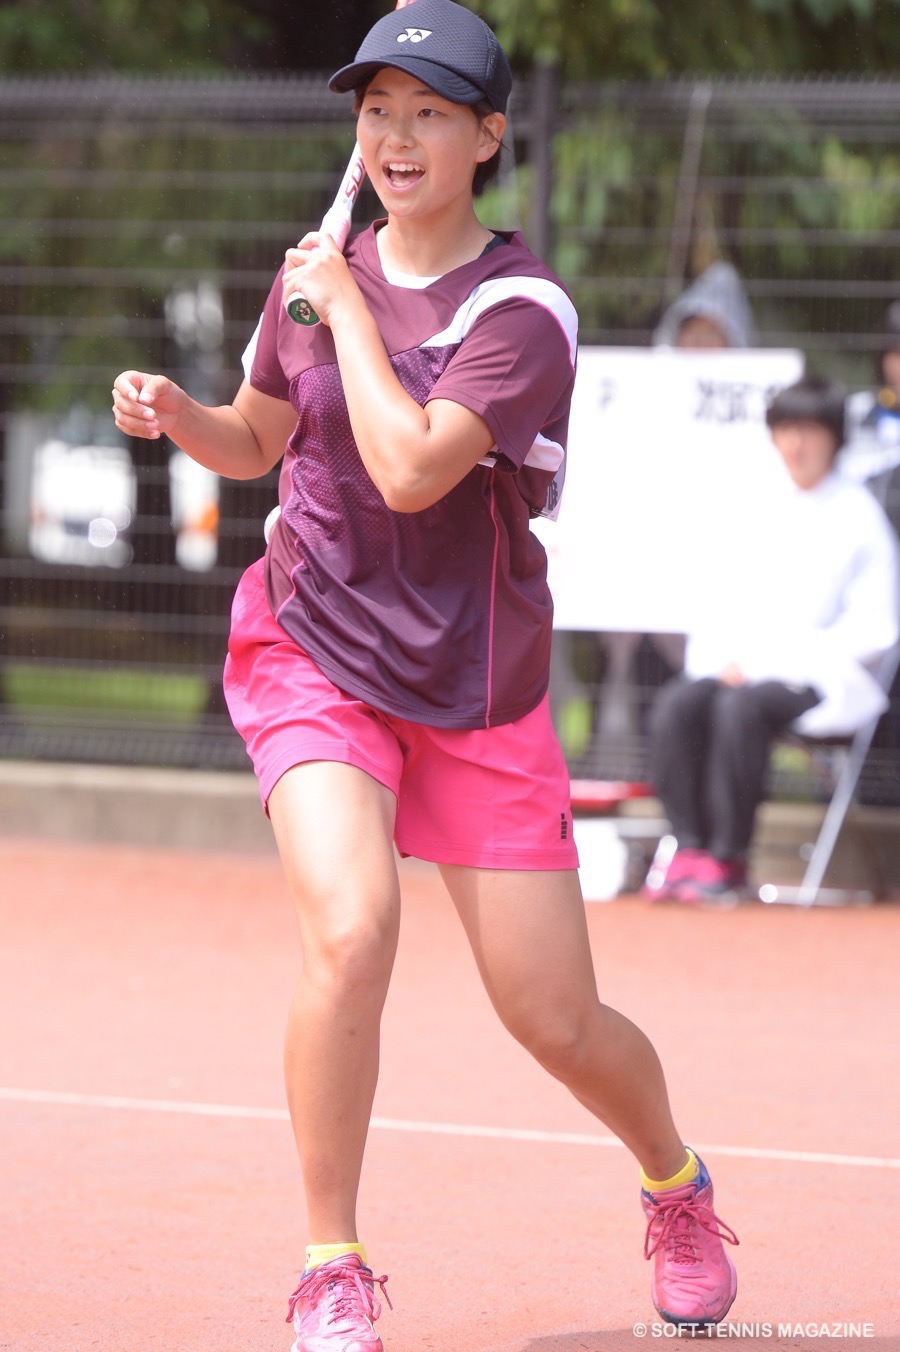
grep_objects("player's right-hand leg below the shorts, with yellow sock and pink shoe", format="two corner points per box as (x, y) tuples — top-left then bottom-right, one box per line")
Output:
(442, 867), (738, 1328)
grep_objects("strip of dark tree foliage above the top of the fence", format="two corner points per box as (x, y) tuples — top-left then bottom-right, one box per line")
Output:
(0, 0), (900, 80)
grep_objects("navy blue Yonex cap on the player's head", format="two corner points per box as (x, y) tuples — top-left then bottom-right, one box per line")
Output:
(328, 0), (512, 112)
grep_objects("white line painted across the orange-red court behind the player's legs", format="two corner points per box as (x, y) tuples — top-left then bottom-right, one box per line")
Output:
(0, 1086), (900, 1169)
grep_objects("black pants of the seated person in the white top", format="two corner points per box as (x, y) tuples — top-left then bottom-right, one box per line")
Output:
(650, 676), (820, 860)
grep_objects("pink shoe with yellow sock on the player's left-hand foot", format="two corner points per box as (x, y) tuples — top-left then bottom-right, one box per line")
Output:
(285, 1253), (391, 1352)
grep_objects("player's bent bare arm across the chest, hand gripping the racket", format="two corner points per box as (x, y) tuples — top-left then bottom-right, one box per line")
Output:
(284, 234), (495, 512)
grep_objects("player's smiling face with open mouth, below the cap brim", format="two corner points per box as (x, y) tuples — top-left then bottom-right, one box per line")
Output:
(357, 66), (505, 215)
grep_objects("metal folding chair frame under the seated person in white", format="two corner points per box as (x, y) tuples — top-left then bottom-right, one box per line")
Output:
(758, 645), (900, 906)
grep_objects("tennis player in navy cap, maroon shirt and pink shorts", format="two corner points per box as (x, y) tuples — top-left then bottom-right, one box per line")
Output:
(114, 0), (736, 1352)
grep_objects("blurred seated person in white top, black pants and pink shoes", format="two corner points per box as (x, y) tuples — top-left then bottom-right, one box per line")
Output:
(645, 376), (900, 903)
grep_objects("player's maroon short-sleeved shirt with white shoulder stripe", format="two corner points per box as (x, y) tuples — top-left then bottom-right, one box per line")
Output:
(245, 226), (577, 729)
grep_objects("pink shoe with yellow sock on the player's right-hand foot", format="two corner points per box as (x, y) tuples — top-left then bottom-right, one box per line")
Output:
(641, 1160), (739, 1328)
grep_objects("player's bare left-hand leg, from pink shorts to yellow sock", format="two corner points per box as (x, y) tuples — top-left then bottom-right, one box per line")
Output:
(269, 761), (400, 1244)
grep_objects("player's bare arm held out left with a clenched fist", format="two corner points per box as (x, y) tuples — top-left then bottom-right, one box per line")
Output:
(112, 370), (297, 479)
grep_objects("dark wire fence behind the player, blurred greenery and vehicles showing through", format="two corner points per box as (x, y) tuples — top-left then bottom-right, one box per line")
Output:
(0, 72), (900, 789)
